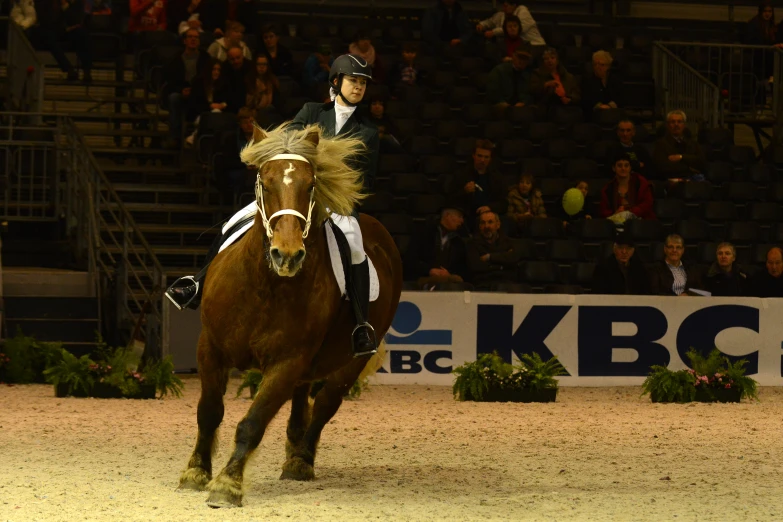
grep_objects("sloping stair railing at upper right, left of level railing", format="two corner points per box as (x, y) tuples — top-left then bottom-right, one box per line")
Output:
(652, 42), (723, 127)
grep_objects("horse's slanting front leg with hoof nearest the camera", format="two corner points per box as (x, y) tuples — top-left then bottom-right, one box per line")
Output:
(207, 360), (305, 507)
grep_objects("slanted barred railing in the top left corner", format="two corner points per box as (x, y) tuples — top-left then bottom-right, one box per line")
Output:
(8, 20), (44, 117)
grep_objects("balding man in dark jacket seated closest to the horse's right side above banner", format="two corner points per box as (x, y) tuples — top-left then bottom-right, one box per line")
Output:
(405, 207), (468, 287)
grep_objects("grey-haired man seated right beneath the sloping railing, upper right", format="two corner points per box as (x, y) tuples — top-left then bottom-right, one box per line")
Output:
(653, 110), (707, 182)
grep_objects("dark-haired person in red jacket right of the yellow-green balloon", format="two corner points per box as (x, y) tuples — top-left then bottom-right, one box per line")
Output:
(599, 151), (655, 225)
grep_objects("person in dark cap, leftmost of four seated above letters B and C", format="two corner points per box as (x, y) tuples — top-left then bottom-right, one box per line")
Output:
(592, 233), (650, 295)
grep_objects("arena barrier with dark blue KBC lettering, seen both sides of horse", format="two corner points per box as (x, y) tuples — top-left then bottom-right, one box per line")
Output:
(168, 292), (783, 386)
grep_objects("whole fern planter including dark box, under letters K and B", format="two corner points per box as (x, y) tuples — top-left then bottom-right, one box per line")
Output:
(452, 353), (565, 402)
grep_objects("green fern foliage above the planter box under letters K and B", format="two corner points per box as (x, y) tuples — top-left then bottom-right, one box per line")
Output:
(452, 353), (565, 401)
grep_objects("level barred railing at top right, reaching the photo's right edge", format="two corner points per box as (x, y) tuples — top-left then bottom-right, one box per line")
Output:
(654, 42), (783, 122)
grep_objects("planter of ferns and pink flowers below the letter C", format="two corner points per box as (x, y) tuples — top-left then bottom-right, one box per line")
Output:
(642, 348), (758, 403)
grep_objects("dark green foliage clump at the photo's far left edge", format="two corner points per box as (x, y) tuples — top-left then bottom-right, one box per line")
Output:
(0, 328), (62, 384)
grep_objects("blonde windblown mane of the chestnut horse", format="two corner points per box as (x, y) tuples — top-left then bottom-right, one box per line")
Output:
(239, 122), (367, 224)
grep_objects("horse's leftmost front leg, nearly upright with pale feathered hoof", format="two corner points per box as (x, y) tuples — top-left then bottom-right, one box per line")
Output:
(178, 336), (228, 491)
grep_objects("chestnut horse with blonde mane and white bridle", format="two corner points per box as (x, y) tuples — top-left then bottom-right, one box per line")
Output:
(179, 124), (402, 507)
